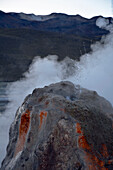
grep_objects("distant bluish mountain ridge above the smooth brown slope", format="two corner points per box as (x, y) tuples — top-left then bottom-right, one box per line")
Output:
(0, 11), (110, 37)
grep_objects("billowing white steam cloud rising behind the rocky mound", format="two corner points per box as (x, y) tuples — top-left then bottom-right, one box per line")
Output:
(0, 18), (113, 165)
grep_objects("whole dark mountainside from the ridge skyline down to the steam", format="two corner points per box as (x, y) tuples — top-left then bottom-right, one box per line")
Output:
(0, 11), (111, 82)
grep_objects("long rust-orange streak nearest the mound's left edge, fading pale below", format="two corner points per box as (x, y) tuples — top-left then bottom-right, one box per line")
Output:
(15, 109), (30, 156)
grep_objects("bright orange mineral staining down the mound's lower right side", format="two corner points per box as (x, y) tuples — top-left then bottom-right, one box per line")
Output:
(76, 123), (108, 170)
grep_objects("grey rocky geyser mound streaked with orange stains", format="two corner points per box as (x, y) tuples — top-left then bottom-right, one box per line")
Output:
(1, 81), (113, 170)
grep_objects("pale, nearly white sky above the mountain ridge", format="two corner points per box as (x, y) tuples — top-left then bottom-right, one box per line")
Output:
(0, 0), (113, 18)
